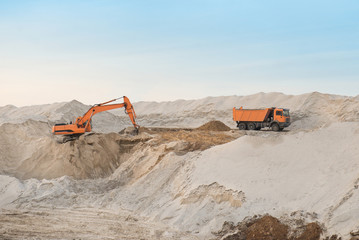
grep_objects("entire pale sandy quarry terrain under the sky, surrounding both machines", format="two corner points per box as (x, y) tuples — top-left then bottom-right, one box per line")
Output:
(0, 93), (359, 239)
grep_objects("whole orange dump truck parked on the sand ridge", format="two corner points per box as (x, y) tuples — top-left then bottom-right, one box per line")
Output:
(233, 107), (290, 131)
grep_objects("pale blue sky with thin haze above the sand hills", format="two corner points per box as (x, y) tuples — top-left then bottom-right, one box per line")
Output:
(0, 0), (359, 106)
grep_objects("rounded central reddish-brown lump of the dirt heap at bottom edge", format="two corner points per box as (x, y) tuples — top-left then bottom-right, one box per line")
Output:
(246, 216), (288, 240)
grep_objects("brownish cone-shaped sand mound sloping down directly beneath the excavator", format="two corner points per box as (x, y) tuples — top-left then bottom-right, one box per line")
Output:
(14, 133), (148, 179)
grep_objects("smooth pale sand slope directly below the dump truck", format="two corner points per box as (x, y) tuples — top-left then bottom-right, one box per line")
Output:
(191, 123), (359, 238)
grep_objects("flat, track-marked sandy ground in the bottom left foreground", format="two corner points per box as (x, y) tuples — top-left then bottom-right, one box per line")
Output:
(0, 208), (198, 240)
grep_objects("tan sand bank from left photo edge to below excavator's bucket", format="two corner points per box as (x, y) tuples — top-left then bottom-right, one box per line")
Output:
(0, 120), (149, 179)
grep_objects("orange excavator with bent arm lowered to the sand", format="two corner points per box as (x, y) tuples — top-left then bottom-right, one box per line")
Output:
(52, 96), (139, 142)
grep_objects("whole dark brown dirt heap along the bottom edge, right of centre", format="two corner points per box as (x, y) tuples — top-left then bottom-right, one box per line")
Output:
(213, 215), (322, 240)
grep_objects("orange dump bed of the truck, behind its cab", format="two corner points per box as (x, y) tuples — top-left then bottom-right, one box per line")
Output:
(233, 107), (271, 122)
